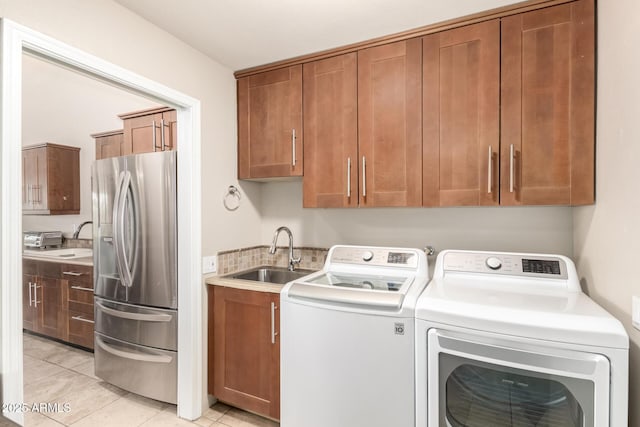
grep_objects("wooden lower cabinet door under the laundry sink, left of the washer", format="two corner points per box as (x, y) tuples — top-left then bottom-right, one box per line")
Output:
(213, 286), (280, 419)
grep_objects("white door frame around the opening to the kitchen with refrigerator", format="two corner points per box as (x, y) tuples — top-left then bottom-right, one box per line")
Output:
(0, 18), (206, 425)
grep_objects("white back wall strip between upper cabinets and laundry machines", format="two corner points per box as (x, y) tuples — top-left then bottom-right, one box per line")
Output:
(261, 181), (573, 256)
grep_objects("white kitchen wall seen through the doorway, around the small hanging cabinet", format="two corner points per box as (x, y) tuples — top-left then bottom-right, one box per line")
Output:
(22, 55), (158, 239)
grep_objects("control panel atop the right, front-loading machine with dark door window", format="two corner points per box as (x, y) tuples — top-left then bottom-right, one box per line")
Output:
(443, 251), (567, 279)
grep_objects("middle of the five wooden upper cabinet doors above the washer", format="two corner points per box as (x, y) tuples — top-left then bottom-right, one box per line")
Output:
(358, 39), (422, 206)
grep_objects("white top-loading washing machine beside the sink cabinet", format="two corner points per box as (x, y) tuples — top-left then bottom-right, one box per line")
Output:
(280, 246), (428, 427)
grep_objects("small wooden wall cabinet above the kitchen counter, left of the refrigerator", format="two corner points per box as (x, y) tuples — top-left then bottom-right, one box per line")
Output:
(22, 143), (80, 215)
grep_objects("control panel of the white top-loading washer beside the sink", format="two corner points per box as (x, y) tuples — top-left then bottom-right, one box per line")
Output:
(329, 246), (418, 268)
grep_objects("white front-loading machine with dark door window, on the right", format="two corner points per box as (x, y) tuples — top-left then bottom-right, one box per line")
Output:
(416, 251), (629, 427)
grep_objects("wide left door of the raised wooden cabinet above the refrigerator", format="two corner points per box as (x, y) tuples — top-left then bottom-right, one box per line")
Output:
(123, 113), (166, 155)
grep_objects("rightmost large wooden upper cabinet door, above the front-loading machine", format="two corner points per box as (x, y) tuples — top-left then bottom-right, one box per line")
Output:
(500, 0), (595, 205)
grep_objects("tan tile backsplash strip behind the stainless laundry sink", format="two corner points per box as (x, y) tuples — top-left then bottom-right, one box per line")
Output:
(218, 246), (329, 275)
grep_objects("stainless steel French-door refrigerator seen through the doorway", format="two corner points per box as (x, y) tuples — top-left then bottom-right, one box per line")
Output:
(92, 151), (178, 403)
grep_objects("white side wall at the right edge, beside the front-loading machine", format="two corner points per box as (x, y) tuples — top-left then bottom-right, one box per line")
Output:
(574, 0), (640, 426)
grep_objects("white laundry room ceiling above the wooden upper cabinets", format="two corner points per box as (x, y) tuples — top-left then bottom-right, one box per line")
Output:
(115, 0), (518, 71)
